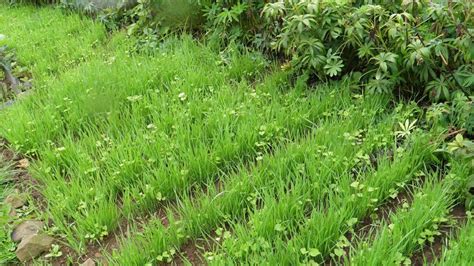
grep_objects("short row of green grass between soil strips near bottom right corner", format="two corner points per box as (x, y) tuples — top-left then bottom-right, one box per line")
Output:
(351, 181), (453, 265)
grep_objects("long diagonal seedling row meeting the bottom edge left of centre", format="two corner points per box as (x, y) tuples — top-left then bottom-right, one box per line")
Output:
(111, 93), (393, 264)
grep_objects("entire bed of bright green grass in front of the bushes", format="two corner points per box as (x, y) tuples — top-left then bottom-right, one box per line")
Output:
(0, 5), (468, 265)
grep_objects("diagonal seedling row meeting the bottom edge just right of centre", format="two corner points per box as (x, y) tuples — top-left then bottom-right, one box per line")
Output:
(206, 124), (433, 265)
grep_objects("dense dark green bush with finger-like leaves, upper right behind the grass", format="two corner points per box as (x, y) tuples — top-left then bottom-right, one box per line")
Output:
(262, 0), (474, 100)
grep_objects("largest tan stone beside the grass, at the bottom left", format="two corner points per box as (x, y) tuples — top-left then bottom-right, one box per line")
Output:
(15, 234), (54, 263)
